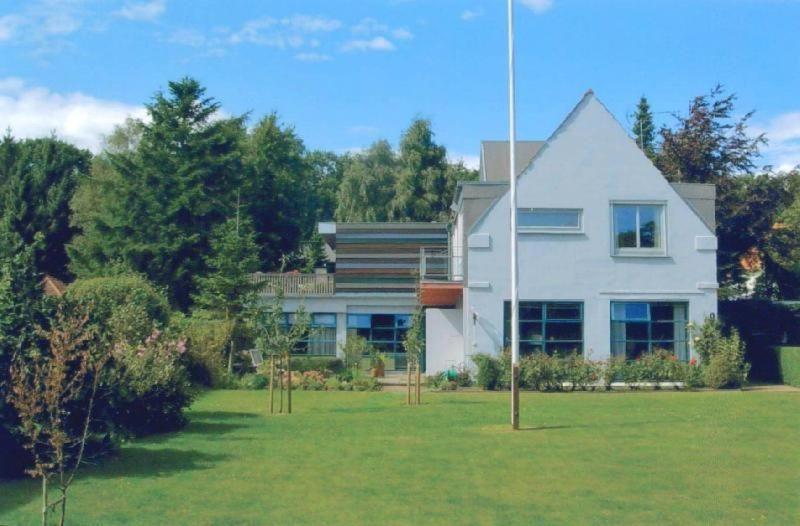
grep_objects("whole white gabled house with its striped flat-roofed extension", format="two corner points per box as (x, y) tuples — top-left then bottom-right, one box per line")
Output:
(258, 92), (717, 373)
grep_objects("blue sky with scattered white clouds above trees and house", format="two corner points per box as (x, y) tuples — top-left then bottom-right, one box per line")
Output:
(0, 0), (800, 171)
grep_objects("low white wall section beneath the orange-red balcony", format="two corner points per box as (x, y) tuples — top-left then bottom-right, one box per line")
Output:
(425, 308), (465, 374)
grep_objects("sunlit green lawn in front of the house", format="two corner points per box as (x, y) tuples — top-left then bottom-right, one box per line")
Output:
(0, 391), (800, 525)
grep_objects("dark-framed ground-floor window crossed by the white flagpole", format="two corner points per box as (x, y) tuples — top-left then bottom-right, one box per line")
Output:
(503, 301), (583, 356)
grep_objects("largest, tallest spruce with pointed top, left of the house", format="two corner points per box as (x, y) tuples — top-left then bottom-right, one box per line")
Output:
(68, 78), (244, 308)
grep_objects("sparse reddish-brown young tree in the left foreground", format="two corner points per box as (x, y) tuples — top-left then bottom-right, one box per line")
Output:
(8, 304), (108, 526)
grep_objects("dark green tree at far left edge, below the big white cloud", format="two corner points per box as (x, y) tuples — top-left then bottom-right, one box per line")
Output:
(0, 134), (91, 279)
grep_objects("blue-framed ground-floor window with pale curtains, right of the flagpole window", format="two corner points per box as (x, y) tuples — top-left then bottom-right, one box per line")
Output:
(611, 301), (689, 360)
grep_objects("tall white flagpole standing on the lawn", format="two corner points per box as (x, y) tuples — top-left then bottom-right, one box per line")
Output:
(508, 0), (519, 429)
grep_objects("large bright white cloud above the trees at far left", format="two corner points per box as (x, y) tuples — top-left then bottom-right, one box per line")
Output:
(0, 77), (146, 152)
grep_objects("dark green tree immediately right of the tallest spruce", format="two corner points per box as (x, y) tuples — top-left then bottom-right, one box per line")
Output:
(242, 113), (316, 268)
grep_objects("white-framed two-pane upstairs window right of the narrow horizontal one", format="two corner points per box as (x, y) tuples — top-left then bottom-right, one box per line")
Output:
(612, 203), (666, 255)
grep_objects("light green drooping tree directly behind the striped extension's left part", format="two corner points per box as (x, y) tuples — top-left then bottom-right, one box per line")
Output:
(336, 140), (398, 222)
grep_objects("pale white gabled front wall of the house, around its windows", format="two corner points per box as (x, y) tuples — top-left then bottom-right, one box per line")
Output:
(463, 95), (717, 359)
